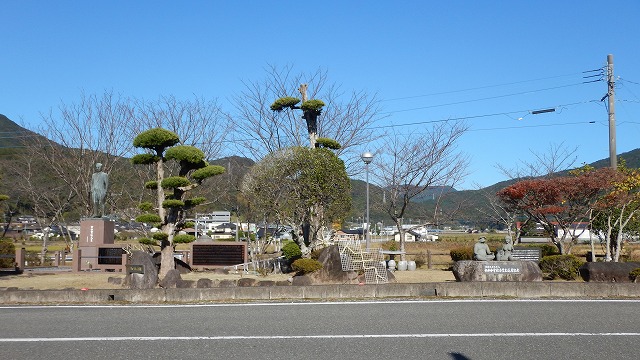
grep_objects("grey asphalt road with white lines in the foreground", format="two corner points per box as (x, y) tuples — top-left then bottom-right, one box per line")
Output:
(0, 300), (640, 360)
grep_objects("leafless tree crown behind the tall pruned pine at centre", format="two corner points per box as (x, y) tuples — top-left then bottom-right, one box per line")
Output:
(230, 66), (380, 174)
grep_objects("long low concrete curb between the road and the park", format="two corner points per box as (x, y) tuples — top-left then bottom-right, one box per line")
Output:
(0, 282), (640, 305)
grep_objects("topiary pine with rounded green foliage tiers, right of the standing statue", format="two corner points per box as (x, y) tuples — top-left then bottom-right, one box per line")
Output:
(131, 128), (225, 279)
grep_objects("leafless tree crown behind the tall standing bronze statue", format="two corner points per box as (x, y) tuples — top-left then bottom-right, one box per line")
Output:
(16, 92), (139, 219)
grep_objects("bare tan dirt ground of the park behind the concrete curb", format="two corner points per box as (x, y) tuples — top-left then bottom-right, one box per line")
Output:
(0, 270), (455, 290)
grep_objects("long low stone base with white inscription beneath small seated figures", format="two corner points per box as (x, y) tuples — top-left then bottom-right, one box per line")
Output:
(452, 260), (542, 281)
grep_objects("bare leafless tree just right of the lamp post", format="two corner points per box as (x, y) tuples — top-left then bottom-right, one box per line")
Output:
(373, 122), (467, 260)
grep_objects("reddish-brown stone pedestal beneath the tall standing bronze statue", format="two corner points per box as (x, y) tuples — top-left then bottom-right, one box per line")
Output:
(73, 218), (115, 270)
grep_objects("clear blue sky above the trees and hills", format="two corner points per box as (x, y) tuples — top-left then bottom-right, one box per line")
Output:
(0, 0), (640, 189)
